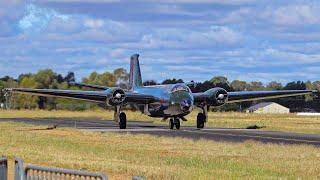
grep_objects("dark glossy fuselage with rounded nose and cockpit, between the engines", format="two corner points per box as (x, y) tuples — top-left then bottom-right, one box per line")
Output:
(133, 84), (194, 117)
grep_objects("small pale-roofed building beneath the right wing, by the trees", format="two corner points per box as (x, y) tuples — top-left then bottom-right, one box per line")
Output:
(246, 102), (290, 114)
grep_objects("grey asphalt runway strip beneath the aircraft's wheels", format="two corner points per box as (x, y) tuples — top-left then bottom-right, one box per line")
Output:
(0, 118), (320, 146)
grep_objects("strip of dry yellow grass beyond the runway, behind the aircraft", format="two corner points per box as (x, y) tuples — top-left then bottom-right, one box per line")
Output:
(0, 110), (320, 134)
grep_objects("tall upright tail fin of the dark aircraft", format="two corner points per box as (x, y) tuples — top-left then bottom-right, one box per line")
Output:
(129, 54), (142, 89)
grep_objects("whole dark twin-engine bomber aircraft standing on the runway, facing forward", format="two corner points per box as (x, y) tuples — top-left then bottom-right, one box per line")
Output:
(5, 54), (317, 129)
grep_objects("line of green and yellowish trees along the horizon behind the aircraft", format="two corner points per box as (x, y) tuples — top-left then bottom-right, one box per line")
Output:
(0, 68), (320, 112)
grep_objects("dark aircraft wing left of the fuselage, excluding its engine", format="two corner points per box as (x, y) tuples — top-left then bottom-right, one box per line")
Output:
(5, 88), (157, 104)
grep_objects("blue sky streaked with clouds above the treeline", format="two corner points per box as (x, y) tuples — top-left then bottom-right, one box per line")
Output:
(0, 0), (320, 83)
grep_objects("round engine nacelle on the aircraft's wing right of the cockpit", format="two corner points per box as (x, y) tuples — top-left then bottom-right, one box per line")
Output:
(204, 88), (228, 106)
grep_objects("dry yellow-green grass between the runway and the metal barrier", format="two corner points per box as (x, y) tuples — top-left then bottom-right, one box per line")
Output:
(0, 122), (320, 179)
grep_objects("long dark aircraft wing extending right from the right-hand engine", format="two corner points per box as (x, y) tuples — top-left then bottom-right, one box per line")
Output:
(227, 90), (317, 103)
